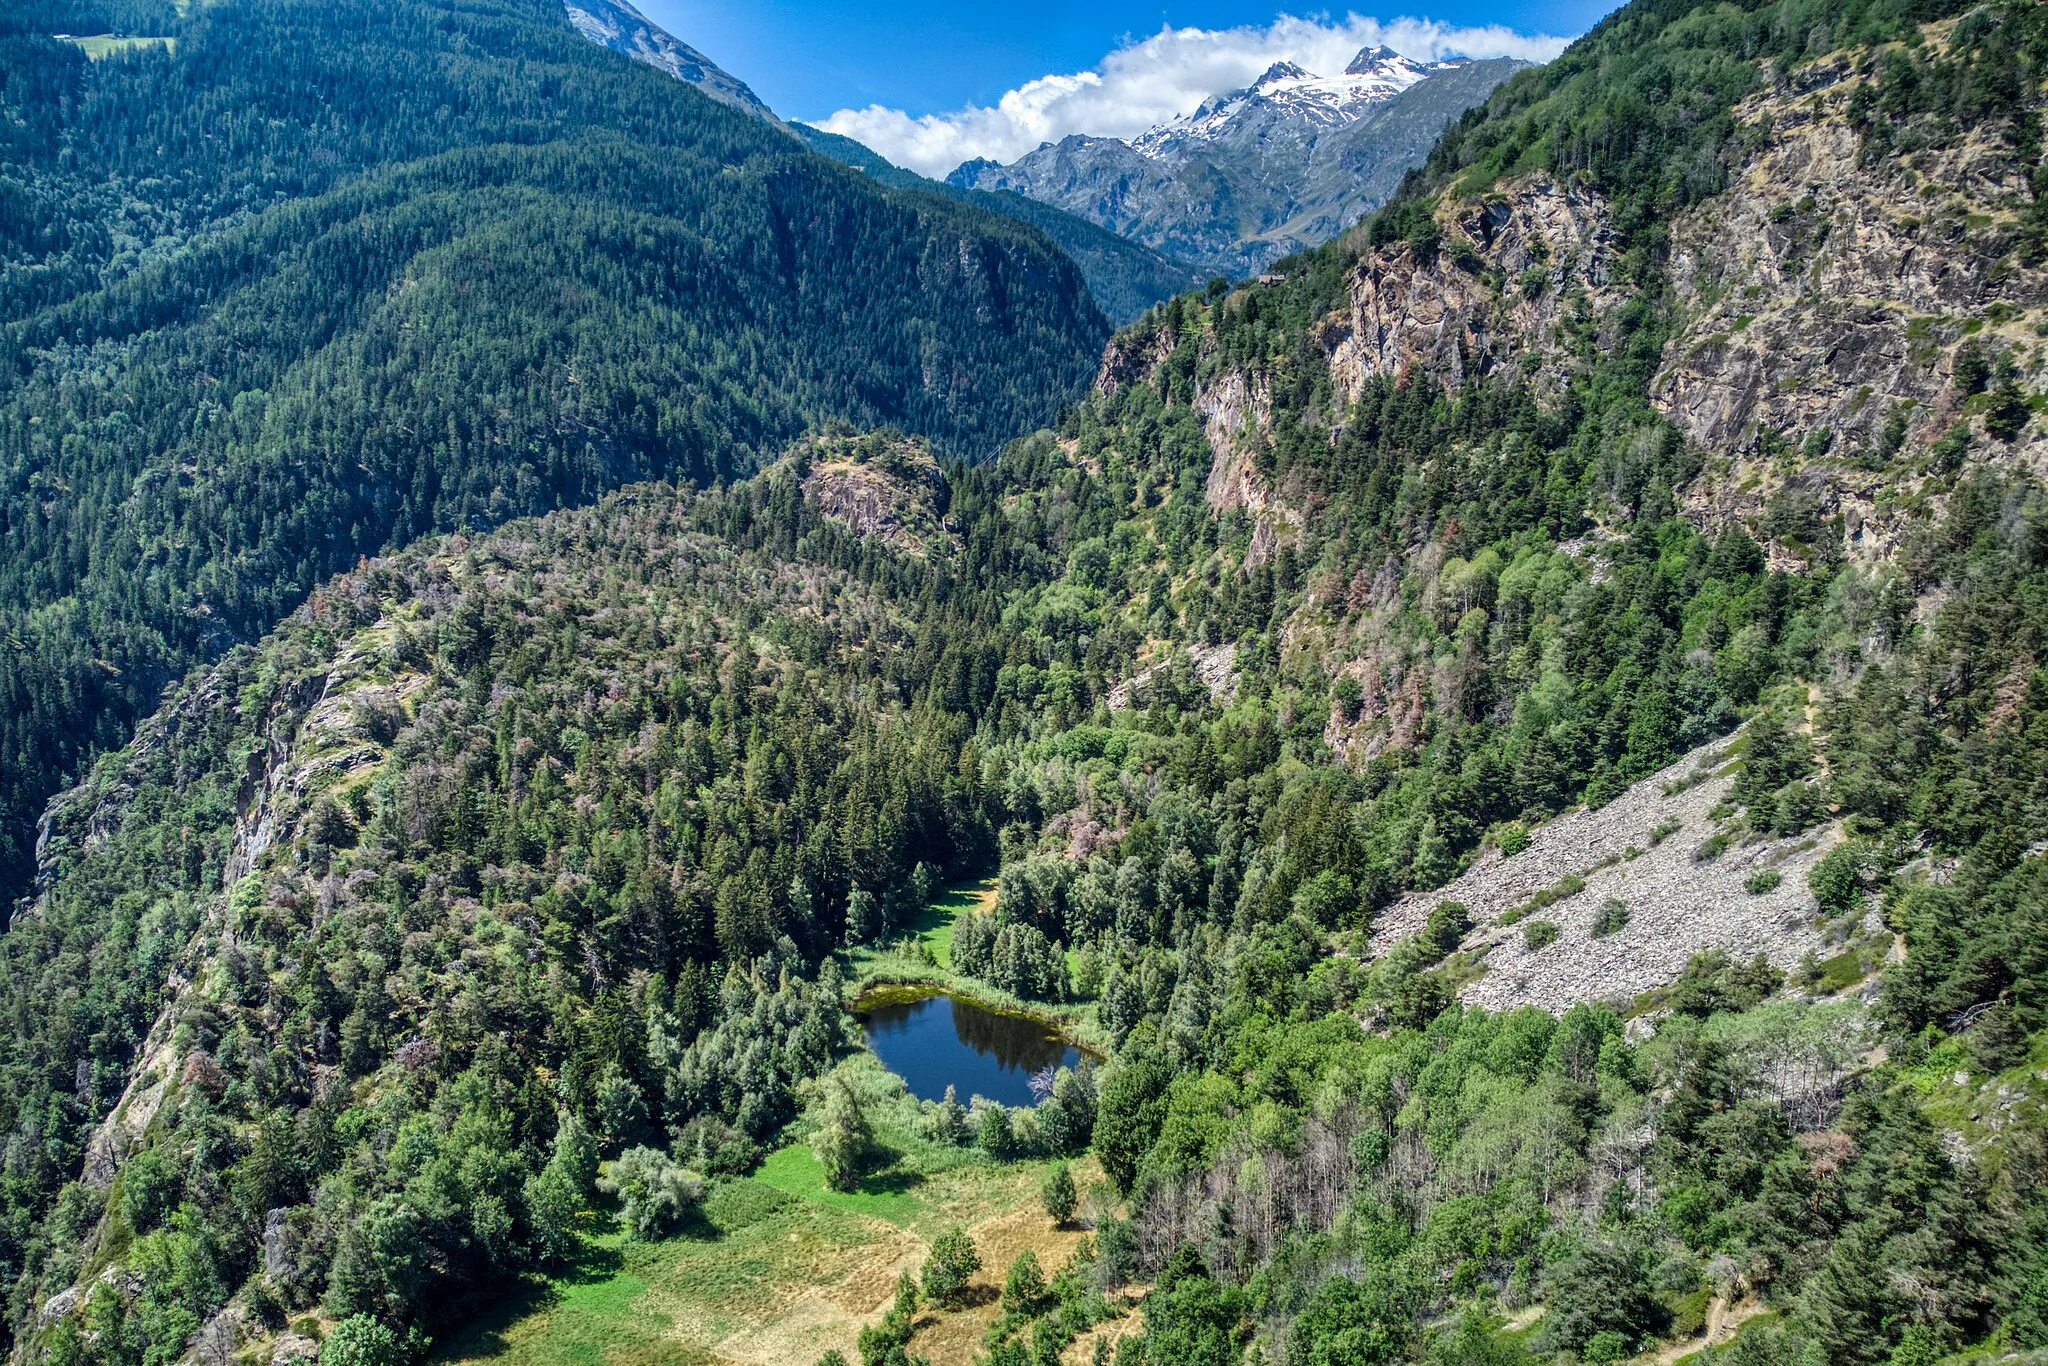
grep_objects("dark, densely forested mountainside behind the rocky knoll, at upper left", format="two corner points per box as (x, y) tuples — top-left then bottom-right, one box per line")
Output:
(0, 0), (1106, 917)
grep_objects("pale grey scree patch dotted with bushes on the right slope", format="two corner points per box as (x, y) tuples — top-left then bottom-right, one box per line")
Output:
(1372, 739), (1841, 1012)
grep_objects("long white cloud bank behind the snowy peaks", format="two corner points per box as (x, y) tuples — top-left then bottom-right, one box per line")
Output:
(817, 14), (1571, 176)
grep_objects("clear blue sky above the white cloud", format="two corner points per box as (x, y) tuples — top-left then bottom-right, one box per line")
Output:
(639, 0), (1612, 121)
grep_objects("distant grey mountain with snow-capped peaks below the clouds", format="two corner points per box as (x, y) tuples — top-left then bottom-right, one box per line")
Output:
(948, 47), (1530, 276)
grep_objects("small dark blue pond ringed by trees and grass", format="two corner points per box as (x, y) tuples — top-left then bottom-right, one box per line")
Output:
(856, 993), (1081, 1106)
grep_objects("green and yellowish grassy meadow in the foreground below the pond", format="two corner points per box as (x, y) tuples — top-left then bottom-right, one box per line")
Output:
(436, 1053), (1102, 1366)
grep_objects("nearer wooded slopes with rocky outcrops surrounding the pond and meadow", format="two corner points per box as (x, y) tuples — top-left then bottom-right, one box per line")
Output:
(0, 0), (2048, 1366)
